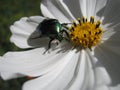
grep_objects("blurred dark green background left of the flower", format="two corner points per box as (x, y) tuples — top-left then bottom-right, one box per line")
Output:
(0, 0), (41, 90)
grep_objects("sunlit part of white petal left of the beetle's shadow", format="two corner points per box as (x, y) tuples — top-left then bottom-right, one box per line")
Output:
(10, 16), (44, 48)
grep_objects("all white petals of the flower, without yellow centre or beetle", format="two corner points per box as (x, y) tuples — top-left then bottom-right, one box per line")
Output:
(0, 0), (120, 90)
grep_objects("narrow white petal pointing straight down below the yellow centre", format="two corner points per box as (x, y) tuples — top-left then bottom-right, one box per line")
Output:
(66, 50), (94, 90)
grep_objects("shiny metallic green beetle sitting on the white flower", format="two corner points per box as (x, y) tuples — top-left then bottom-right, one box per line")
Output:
(38, 19), (68, 49)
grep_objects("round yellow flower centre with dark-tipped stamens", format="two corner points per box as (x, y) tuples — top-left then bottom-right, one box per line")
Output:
(69, 17), (103, 49)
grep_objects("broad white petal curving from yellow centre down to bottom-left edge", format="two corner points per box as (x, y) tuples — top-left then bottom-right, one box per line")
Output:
(23, 50), (79, 90)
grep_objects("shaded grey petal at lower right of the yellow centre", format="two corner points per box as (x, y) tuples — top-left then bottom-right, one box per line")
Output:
(95, 43), (120, 85)
